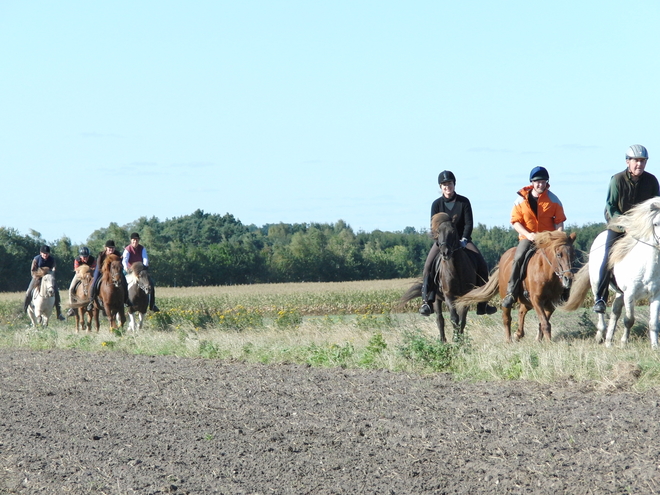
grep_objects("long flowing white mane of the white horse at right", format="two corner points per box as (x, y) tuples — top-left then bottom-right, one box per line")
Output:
(607, 198), (660, 268)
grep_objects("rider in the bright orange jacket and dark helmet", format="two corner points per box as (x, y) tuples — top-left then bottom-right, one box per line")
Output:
(502, 167), (566, 308)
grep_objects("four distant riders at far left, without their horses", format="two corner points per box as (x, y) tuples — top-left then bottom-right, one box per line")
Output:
(24, 232), (159, 320)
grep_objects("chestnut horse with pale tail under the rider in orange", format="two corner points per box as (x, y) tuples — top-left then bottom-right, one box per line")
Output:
(458, 230), (576, 342)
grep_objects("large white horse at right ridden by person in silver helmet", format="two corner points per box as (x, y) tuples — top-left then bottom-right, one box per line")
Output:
(562, 198), (660, 349)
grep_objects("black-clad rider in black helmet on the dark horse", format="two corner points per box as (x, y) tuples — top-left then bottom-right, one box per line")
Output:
(419, 170), (497, 316)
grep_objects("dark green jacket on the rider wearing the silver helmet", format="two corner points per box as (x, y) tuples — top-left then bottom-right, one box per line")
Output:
(605, 169), (660, 222)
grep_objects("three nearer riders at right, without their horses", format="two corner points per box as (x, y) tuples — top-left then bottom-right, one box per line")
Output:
(419, 144), (660, 324)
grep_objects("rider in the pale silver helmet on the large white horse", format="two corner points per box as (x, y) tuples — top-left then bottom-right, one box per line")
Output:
(593, 144), (660, 313)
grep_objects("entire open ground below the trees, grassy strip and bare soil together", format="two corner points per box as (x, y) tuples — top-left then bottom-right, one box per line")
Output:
(0, 280), (660, 495)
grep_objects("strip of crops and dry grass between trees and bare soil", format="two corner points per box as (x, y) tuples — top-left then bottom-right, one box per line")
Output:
(0, 279), (660, 390)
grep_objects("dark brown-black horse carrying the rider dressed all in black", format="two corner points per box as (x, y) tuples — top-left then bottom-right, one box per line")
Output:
(401, 213), (478, 342)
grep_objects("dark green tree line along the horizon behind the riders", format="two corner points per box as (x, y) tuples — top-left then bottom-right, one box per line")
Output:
(0, 210), (605, 292)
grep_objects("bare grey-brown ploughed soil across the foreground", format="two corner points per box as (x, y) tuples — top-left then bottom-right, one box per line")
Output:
(0, 351), (660, 495)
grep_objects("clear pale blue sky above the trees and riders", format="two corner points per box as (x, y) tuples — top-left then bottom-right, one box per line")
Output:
(0, 0), (660, 243)
